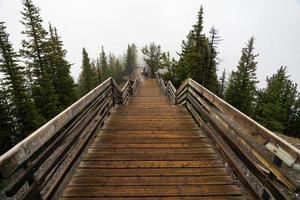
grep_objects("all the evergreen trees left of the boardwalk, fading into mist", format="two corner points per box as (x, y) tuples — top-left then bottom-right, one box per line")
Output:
(0, 0), (137, 155)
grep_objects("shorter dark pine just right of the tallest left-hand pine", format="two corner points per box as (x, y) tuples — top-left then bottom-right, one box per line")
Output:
(47, 24), (76, 110)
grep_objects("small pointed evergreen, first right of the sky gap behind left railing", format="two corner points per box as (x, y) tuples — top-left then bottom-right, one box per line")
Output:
(78, 48), (98, 96)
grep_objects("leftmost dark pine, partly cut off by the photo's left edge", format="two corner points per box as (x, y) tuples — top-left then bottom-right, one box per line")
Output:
(0, 22), (42, 141)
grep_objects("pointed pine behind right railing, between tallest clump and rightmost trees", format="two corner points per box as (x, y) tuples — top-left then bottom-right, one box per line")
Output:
(225, 37), (258, 116)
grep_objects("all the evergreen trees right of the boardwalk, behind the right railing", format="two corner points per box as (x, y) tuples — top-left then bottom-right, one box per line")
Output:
(152, 6), (300, 137)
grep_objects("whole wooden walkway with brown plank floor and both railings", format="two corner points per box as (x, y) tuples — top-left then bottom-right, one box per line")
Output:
(0, 72), (300, 200)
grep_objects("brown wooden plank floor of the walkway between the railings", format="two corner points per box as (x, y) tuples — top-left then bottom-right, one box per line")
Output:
(61, 79), (243, 200)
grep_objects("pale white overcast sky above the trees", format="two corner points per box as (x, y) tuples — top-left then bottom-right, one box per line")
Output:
(0, 0), (300, 87)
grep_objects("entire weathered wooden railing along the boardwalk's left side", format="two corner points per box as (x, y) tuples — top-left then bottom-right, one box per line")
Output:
(0, 78), (139, 199)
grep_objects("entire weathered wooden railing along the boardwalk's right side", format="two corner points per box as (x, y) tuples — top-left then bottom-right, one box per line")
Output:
(157, 75), (300, 199)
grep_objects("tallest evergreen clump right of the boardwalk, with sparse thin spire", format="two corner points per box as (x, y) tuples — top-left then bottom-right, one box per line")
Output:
(176, 6), (220, 92)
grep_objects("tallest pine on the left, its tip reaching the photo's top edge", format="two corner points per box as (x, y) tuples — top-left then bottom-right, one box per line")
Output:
(20, 0), (58, 120)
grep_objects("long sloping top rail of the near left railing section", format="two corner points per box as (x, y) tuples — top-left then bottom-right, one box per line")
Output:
(0, 78), (111, 177)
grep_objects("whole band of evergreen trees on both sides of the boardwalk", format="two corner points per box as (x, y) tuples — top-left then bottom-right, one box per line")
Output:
(0, 0), (300, 154)
